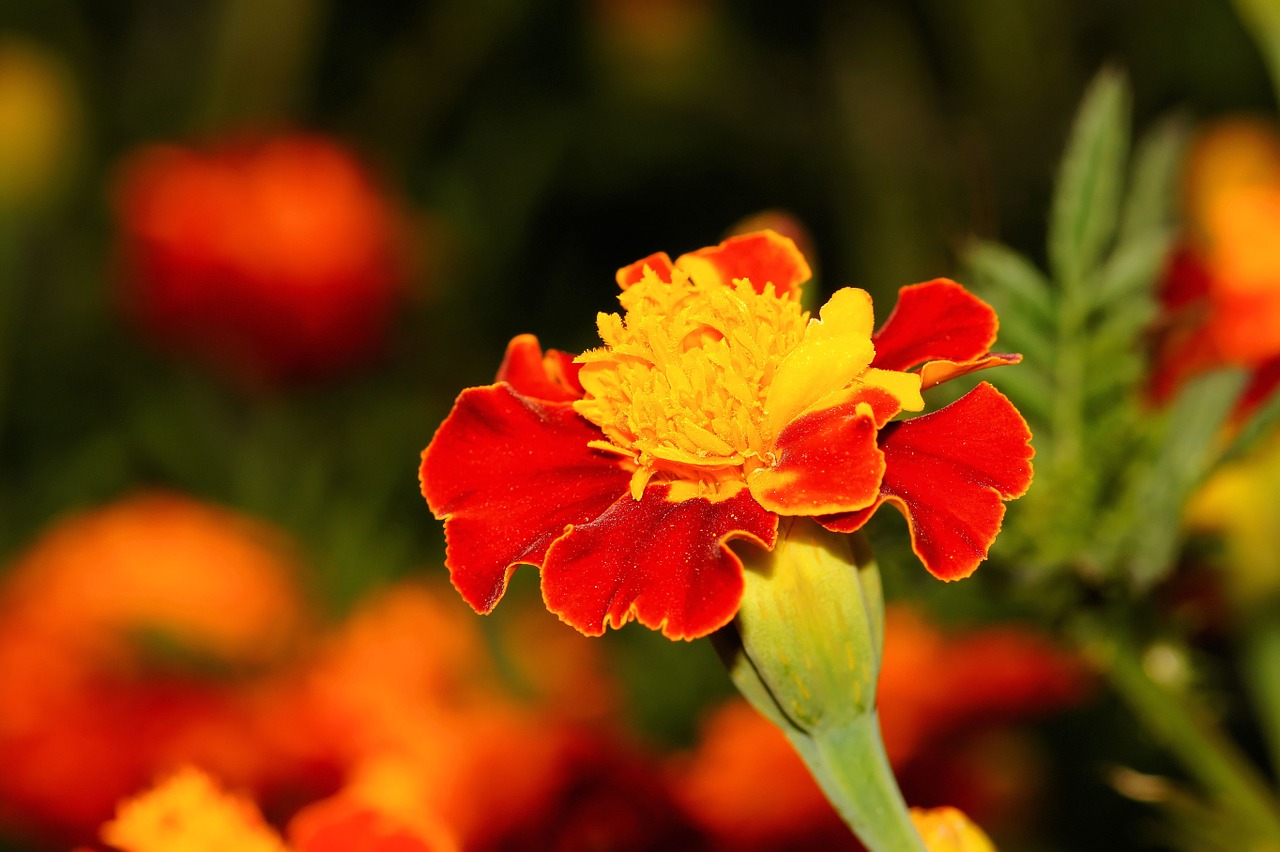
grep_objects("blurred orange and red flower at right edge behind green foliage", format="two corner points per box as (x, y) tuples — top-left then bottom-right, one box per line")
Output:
(1152, 118), (1280, 411)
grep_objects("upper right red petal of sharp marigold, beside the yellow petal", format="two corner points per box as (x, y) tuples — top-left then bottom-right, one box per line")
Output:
(872, 278), (1000, 371)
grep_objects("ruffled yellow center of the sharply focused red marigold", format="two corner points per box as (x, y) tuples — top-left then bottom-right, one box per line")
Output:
(575, 270), (809, 500)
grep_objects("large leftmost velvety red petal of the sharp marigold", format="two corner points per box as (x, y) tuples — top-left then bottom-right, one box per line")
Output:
(420, 384), (631, 613)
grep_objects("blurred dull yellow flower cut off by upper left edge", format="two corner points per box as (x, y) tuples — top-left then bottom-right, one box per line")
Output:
(0, 37), (79, 214)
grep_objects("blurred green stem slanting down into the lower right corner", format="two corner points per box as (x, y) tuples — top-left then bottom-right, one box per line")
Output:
(1079, 611), (1280, 844)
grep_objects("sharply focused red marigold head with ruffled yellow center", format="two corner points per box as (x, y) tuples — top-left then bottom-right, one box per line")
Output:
(421, 232), (1032, 638)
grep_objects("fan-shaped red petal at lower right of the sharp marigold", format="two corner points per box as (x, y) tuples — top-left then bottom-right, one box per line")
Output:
(820, 383), (1034, 580)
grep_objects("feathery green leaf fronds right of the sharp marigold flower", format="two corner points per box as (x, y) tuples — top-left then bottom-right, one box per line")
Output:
(965, 70), (1218, 586)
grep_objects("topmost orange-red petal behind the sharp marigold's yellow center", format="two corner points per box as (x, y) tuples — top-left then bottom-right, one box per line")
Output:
(676, 230), (813, 298)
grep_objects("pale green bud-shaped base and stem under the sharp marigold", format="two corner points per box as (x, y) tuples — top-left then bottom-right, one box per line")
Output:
(713, 518), (924, 852)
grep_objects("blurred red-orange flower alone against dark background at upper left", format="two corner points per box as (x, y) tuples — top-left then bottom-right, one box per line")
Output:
(115, 136), (406, 381)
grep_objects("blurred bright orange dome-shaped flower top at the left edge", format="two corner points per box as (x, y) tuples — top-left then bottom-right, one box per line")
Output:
(0, 493), (302, 667)
